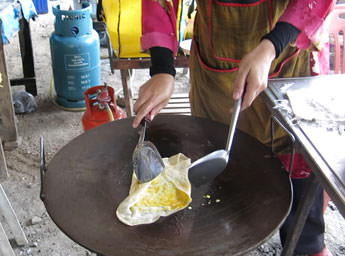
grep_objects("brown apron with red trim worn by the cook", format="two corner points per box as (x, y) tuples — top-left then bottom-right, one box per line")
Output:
(190, 0), (311, 147)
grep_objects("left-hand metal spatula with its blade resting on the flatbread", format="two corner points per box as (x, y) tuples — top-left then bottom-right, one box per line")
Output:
(132, 117), (164, 183)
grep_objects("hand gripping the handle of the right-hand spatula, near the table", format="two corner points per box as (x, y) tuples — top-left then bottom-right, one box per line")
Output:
(233, 39), (276, 110)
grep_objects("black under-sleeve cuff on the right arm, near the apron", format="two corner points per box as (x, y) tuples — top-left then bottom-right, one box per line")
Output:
(261, 22), (301, 58)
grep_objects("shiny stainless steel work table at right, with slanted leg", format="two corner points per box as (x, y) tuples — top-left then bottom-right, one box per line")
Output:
(262, 75), (345, 255)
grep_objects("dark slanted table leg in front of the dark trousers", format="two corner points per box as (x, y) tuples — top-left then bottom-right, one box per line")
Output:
(281, 173), (320, 256)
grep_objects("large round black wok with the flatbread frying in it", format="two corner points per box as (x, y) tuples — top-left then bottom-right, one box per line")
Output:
(41, 115), (291, 256)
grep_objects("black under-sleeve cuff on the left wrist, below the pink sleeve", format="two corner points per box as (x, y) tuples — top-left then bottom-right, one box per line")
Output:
(150, 47), (176, 77)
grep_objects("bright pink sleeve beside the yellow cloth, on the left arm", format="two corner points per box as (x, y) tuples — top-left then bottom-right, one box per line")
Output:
(141, 0), (178, 54)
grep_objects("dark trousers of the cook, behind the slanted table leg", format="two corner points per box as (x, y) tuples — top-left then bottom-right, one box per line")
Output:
(280, 178), (325, 254)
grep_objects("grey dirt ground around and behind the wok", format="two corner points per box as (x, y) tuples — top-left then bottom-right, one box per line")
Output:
(3, 0), (345, 256)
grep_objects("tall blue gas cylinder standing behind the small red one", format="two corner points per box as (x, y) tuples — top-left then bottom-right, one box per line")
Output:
(50, 5), (101, 108)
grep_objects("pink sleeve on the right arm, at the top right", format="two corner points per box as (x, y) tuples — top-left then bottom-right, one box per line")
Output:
(279, 0), (336, 49)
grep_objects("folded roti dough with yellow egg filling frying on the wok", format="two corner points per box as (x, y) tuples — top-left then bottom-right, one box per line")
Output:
(116, 153), (192, 226)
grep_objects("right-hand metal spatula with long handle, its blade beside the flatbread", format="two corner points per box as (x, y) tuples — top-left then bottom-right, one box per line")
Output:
(188, 99), (242, 186)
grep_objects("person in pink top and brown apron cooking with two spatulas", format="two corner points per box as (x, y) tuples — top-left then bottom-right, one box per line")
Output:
(133, 0), (335, 255)
